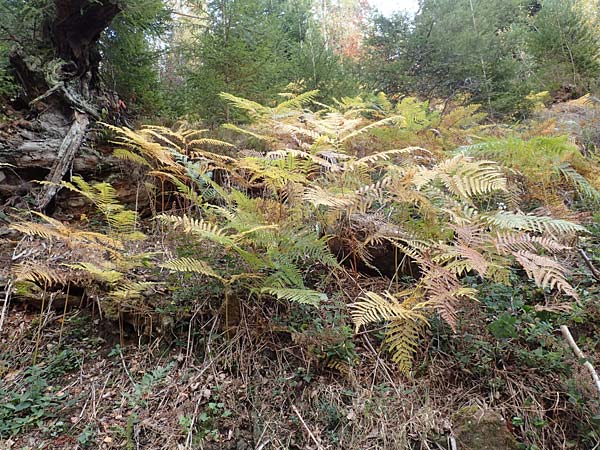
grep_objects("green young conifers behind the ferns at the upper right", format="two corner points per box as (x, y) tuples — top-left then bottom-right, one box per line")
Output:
(360, 0), (600, 117)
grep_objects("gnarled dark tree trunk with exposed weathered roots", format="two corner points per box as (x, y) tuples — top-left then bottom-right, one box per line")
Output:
(0, 0), (121, 210)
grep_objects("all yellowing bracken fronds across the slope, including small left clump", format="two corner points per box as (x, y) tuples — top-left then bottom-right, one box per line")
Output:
(9, 91), (598, 373)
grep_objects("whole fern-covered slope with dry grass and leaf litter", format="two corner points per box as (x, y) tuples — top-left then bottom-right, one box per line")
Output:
(0, 91), (600, 449)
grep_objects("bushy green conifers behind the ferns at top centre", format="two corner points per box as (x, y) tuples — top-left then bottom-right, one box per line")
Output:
(166, 0), (357, 124)
